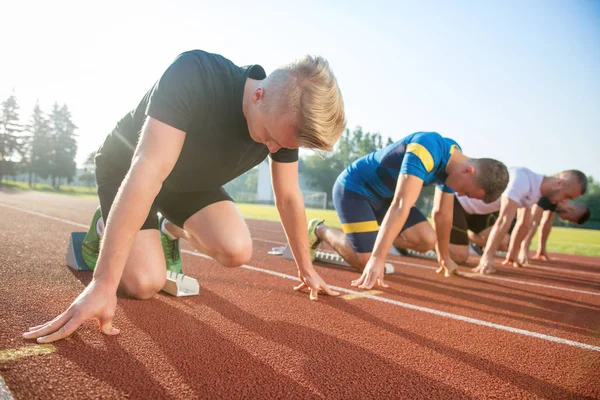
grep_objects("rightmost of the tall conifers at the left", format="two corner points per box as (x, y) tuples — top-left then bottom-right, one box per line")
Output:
(50, 103), (77, 189)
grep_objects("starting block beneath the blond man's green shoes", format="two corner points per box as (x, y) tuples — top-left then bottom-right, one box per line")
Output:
(66, 232), (200, 297)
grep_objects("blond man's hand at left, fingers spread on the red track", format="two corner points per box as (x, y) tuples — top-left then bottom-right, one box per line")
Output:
(23, 280), (119, 343)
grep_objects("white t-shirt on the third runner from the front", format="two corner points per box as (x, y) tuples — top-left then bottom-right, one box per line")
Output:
(457, 167), (544, 215)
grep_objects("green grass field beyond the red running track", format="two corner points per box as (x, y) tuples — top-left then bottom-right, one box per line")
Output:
(2, 181), (600, 257)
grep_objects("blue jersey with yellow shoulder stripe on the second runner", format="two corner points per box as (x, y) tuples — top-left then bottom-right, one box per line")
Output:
(338, 132), (461, 199)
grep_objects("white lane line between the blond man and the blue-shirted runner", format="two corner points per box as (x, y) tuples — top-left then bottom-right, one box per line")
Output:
(182, 250), (600, 352)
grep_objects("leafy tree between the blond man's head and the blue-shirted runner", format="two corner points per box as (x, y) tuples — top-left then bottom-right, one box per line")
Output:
(302, 126), (393, 205)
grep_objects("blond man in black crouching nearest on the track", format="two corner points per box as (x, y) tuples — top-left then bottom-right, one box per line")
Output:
(24, 50), (345, 343)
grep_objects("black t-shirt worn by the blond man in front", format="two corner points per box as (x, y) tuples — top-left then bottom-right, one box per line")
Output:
(98, 50), (298, 192)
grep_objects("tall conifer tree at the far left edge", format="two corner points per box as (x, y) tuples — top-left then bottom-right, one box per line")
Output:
(0, 94), (22, 183)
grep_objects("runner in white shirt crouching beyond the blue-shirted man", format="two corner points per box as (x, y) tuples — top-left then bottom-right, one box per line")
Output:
(472, 167), (587, 274)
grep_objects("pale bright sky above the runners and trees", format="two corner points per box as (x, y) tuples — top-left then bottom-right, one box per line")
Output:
(0, 0), (600, 179)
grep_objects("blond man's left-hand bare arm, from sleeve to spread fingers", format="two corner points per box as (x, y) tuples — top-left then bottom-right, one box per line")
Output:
(23, 118), (185, 343)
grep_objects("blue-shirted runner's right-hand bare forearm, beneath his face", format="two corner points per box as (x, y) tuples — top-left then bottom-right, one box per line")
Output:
(431, 188), (454, 266)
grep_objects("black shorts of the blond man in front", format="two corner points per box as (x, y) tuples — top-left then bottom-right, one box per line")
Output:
(96, 155), (233, 229)
